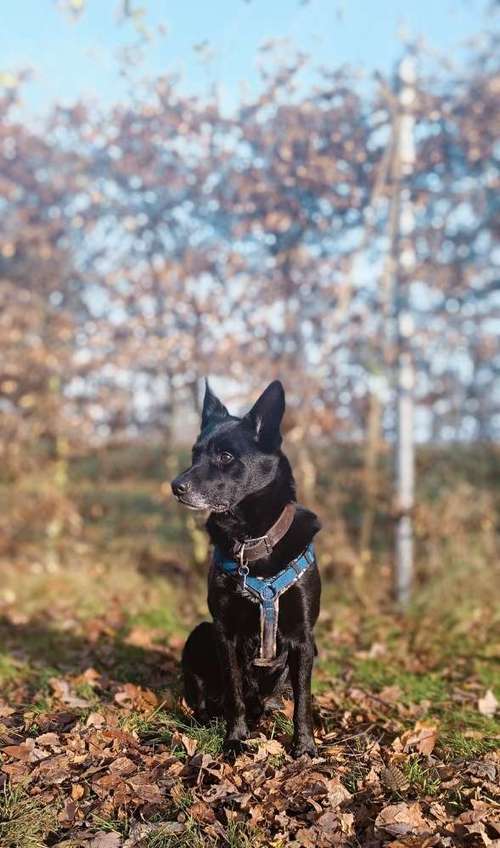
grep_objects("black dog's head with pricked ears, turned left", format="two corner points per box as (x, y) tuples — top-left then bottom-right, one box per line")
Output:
(172, 380), (285, 512)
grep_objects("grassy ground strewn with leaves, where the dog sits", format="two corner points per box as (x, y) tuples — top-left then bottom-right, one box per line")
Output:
(0, 564), (500, 848)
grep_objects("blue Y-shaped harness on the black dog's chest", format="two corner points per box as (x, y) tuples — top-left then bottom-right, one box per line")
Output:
(214, 543), (315, 666)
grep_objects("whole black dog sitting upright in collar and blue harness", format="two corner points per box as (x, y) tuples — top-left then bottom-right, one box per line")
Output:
(172, 381), (321, 757)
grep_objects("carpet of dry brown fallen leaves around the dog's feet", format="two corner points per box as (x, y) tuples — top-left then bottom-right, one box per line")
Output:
(0, 632), (500, 848)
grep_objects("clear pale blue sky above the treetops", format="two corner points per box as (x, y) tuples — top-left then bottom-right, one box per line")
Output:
(0, 0), (492, 115)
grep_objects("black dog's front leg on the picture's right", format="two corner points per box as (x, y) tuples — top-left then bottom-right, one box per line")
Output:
(288, 638), (316, 757)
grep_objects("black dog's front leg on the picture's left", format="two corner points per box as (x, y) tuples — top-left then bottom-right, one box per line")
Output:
(216, 625), (248, 754)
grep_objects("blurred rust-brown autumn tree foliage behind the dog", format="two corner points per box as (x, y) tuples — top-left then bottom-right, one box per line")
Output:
(0, 40), (498, 458)
